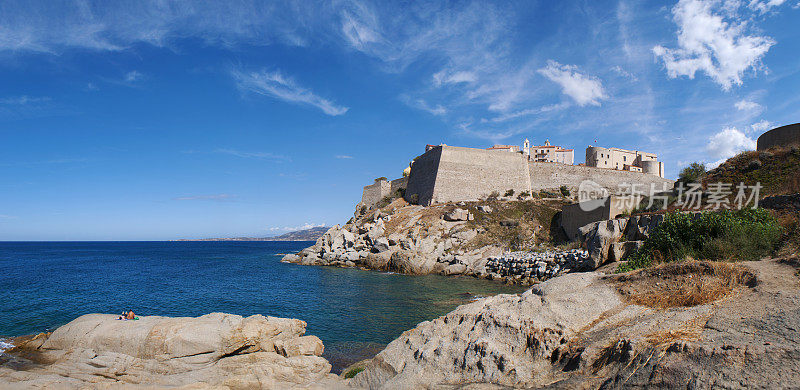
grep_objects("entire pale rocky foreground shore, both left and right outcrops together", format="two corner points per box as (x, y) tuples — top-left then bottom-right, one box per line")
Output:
(0, 259), (800, 389)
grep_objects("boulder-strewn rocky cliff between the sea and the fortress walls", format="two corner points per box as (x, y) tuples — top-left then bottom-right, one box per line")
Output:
(283, 199), (587, 284)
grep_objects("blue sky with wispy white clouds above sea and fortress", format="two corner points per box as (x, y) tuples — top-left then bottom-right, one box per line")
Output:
(0, 0), (800, 241)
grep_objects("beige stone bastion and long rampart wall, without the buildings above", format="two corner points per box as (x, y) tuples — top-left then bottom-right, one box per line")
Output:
(404, 145), (674, 205)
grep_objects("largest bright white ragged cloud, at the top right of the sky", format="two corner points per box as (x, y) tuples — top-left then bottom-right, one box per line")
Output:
(653, 0), (775, 90)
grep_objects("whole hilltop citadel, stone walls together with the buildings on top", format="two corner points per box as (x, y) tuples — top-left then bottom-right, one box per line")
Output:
(361, 139), (674, 207)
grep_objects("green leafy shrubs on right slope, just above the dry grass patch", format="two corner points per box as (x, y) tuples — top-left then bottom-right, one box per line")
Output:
(617, 209), (782, 272)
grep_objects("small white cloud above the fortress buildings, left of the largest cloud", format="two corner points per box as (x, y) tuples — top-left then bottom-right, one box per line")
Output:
(537, 60), (606, 106)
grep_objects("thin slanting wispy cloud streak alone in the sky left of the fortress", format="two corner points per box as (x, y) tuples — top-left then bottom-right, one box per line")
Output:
(231, 70), (348, 116)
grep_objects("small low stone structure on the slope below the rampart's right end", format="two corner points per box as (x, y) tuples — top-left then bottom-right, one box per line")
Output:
(561, 196), (638, 240)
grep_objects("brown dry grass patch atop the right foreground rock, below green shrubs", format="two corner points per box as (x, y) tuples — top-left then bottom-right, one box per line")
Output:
(611, 260), (756, 309)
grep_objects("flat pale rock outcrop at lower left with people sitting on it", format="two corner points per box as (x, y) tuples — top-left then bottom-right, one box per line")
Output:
(0, 313), (343, 389)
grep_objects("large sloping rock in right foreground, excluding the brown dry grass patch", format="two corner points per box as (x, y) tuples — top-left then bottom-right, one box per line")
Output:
(351, 260), (800, 389)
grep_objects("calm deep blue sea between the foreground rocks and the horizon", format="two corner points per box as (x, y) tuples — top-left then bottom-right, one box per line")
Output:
(0, 242), (522, 372)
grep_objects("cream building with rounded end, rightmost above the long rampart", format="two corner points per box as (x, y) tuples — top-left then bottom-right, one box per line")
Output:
(586, 146), (664, 177)
